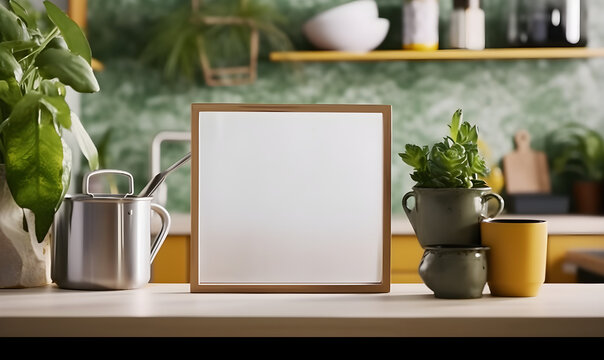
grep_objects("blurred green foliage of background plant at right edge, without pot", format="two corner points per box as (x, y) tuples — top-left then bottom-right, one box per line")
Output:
(545, 123), (604, 181)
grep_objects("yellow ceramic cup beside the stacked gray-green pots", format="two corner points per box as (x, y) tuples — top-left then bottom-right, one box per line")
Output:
(480, 219), (547, 296)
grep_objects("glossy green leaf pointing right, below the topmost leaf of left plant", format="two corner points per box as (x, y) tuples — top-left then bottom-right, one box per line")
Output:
(36, 48), (99, 93)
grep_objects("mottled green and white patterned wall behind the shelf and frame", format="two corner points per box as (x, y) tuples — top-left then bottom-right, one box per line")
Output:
(81, 0), (604, 213)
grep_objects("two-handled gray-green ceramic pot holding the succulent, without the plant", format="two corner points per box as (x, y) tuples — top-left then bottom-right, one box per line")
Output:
(402, 187), (504, 248)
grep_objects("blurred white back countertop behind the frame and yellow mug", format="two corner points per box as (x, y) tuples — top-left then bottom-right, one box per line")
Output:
(170, 213), (604, 235)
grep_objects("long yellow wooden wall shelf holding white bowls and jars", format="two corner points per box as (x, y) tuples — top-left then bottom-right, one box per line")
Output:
(270, 47), (604, 62)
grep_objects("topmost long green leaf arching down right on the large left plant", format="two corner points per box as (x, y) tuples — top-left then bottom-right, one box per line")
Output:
(44, 1), (92, 64)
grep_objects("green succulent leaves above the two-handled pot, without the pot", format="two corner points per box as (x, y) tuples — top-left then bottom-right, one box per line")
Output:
(399, 109), (489, 188)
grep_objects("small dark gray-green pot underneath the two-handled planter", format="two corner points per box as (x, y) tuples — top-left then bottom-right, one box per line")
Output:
(419, 246), (489, 299)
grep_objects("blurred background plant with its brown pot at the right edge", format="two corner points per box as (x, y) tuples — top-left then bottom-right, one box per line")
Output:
(545, 123), (604, 214)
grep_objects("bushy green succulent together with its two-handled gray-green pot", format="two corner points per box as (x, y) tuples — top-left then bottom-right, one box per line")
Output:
(399, 109), (504, 248)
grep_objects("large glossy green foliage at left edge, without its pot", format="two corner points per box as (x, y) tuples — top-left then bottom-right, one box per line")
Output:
(0, 0), (99, 242)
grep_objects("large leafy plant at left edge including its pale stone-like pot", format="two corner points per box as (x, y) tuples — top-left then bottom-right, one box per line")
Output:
(0, 0), (99, 288)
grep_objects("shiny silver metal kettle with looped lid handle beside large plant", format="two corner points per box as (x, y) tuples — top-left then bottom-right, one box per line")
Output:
(51, 170), (171, 290)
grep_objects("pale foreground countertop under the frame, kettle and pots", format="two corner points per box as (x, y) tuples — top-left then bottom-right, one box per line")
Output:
(0, 284), (604, 337)
